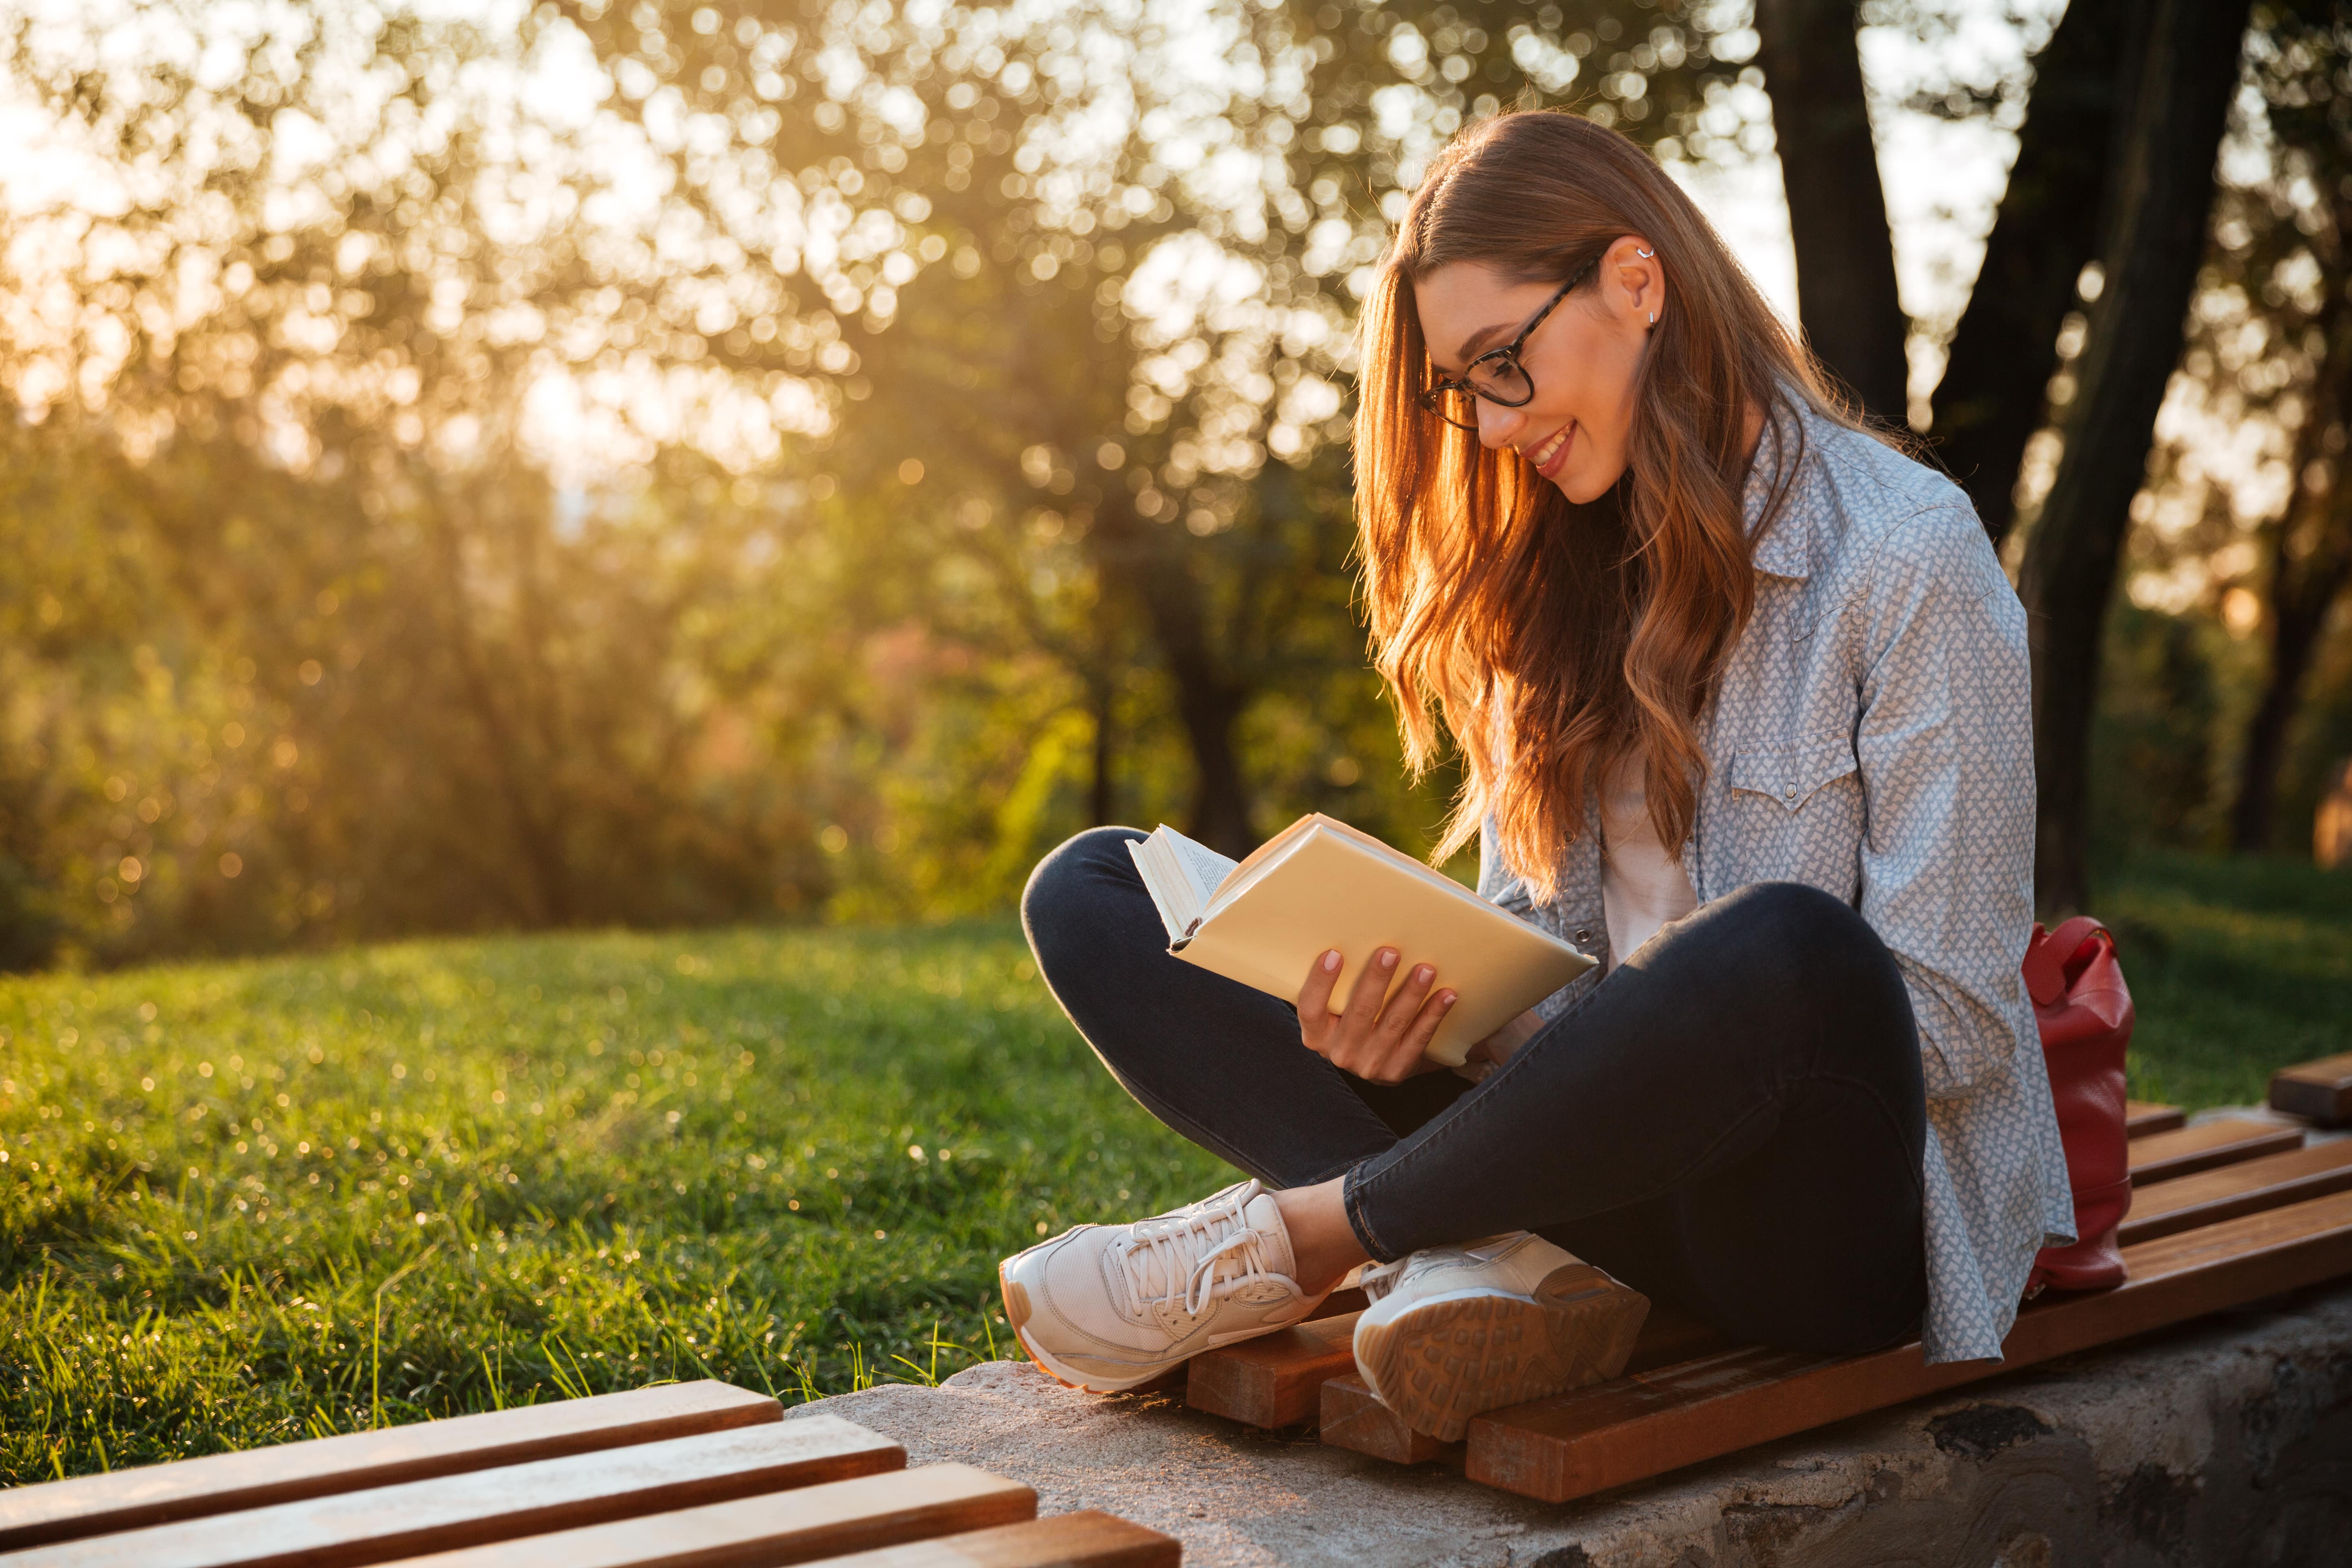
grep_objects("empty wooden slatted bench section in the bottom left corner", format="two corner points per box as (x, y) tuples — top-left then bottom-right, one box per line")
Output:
(0, 1382), (1181, 1568)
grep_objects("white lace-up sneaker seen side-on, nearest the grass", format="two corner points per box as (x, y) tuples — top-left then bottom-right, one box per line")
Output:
(997, 1180), (1327, 1394)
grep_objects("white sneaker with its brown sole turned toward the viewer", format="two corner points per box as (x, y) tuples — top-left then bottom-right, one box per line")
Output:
(1355, 1232), (1649, 1443)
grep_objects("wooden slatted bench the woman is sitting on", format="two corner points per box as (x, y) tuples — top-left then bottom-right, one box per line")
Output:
(1188, 1086), (2352, 1502)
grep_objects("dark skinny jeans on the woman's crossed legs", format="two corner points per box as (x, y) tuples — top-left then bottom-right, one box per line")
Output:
(1021, 828), (1926, 1354)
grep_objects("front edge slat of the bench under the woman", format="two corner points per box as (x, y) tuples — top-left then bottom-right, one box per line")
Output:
(1468, 1192), (2352, 1502)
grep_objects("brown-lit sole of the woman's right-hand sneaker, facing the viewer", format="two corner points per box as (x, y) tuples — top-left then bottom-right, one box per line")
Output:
(1355, 1263), (1649, 1443)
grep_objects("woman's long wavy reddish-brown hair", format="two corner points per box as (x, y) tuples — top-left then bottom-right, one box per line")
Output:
(1355, 111), (1851, 898)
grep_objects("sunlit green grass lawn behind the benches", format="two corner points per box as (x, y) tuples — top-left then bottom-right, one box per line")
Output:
(0, 858), (2352, 1483)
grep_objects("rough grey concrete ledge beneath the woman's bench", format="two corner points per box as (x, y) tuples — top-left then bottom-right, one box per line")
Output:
(793, 1283), (2352, 1568)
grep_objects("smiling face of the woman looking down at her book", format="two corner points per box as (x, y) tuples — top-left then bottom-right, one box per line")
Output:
(1414, 235), (1665, 503)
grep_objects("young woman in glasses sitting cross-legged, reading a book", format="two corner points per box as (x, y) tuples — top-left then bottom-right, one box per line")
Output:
(1000, 113), (2074, 1434)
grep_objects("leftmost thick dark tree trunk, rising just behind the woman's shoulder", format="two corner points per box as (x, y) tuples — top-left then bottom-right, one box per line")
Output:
(1757, 0), (1910, 425)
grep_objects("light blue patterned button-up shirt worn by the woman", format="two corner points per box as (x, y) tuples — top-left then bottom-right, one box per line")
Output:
(1479, 392), (2074, 1361)
